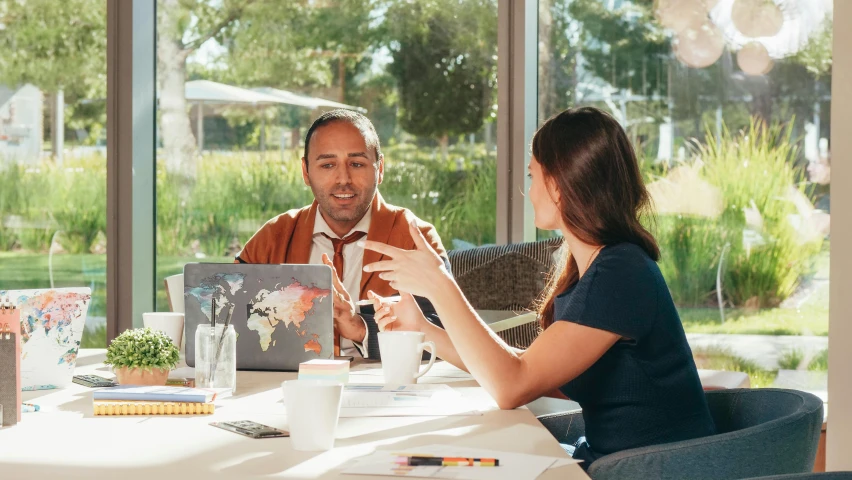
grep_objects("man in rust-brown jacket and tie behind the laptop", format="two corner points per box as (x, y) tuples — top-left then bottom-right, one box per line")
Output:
(236, 110), (449, 359)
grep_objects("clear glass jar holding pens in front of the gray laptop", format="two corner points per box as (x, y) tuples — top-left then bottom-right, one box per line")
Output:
(195, 324), (237, 393)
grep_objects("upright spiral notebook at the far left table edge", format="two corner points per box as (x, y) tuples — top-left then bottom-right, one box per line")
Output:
(0, 299), (21, 427)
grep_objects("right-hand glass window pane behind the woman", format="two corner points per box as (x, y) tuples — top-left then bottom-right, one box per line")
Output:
(538, 0), (833, 395)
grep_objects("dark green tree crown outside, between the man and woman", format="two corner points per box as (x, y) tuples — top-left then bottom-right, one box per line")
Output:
(385, 0), (497, 151)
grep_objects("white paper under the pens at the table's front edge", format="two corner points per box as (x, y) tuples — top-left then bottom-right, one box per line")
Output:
(343, 445), (579, 480)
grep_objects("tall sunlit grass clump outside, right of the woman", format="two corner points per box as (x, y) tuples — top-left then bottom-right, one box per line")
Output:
(698, 119), (822, 306)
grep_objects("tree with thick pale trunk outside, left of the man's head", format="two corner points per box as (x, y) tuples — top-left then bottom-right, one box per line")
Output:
(157, 0), (376, 178)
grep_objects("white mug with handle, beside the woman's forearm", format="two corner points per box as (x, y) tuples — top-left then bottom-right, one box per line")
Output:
(379, 331), (435, 385)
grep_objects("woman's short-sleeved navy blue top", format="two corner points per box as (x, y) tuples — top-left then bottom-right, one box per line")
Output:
(554, 243), (715, 467)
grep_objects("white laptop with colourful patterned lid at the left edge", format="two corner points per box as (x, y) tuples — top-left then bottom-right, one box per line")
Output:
(0, 287), (92, 390)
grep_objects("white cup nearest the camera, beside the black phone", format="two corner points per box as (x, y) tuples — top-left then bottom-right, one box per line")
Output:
(281, 380), (343, 452)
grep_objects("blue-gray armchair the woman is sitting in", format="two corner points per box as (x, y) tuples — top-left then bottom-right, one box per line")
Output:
(539, 388), (823, 480)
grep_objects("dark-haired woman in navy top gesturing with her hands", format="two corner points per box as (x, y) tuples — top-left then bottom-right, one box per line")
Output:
(364, 108), (715, 468)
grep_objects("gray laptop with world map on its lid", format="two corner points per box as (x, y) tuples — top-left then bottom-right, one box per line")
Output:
(183, 263), (334, 371)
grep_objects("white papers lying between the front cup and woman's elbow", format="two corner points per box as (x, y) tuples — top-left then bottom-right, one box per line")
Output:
(340, 384), (481, 417)
